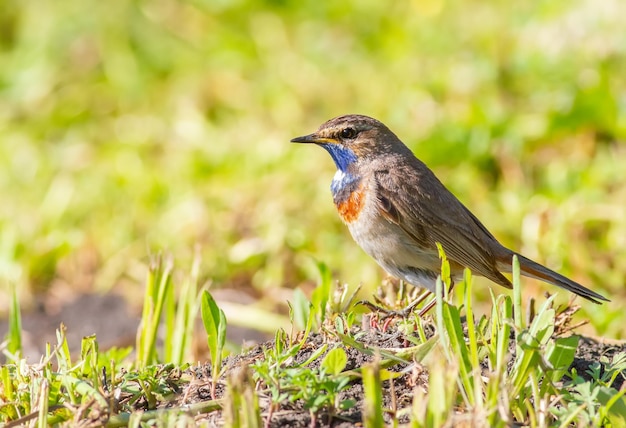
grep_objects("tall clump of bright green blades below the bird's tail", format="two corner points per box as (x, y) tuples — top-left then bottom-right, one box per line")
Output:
(422, 247), (604, 427)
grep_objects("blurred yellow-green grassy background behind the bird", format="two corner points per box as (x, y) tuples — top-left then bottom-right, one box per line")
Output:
(0, 0), (626, 337)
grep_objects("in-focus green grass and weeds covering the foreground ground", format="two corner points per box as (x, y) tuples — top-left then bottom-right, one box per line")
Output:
(0, 254), (626, 427)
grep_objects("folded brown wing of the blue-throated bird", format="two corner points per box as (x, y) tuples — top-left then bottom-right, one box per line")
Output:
(375, 158), (512, 288)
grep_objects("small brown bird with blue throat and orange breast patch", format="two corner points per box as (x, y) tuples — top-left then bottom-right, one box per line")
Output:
(291, 114), (610, 304)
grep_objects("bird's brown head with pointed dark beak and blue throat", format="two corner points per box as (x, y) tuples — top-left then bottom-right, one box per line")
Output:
(291, 114), (406, 172)
